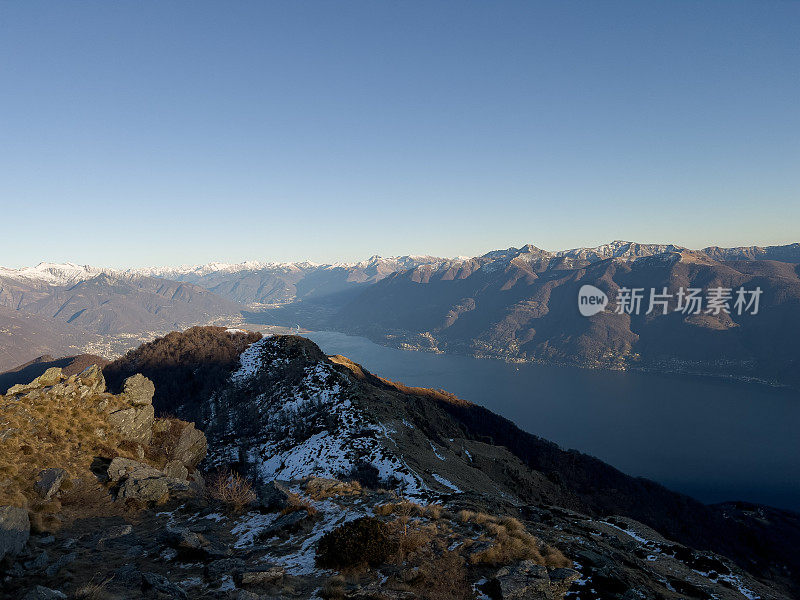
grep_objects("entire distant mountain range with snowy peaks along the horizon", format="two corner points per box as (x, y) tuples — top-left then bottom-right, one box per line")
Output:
(0, 241), (800, 386)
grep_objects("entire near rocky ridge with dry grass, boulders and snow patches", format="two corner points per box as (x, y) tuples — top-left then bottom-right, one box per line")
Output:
(0, 327), (800, 600)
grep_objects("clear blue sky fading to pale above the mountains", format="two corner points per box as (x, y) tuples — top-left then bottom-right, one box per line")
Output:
(0, 0), (800, 267)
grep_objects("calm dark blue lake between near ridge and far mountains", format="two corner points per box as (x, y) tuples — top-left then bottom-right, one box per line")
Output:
(307, 332), (800, 510)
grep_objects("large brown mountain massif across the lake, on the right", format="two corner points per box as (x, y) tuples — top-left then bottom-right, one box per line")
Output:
(332, 247), (800, 385)
